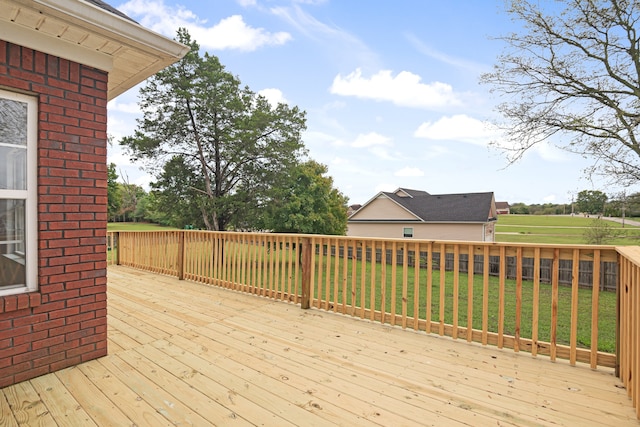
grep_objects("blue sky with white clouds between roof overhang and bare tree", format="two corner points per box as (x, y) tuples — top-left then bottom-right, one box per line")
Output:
(109, 0), (624, 204)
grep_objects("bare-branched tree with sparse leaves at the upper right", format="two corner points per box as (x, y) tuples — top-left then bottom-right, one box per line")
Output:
(481, 0), (640, 184)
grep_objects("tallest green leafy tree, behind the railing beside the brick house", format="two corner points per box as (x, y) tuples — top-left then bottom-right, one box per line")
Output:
(121, 29), (306, 230)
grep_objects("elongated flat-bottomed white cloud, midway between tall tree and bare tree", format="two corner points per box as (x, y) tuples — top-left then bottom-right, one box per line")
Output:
(330, 68), (461, 108)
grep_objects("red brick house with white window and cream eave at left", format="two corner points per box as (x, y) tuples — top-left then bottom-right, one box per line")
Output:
(0, 0), (188, 387)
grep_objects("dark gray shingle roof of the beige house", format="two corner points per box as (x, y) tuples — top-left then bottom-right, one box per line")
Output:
(383, 188), (493, 222)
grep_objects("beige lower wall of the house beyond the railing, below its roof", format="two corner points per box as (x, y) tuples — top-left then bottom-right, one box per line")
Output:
(347, 222), (493, 241)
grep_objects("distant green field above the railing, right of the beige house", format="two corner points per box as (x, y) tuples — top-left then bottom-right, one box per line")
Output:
(496, 215), (640, 246)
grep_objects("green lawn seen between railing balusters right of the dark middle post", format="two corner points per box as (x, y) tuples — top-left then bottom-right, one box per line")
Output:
(314, 257), (616, 352)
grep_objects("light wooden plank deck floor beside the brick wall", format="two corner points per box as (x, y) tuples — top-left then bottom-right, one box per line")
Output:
(0, 267), (640, 427)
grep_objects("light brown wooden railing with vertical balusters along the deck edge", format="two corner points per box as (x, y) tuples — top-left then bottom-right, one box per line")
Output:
(107, 231), (640, 418)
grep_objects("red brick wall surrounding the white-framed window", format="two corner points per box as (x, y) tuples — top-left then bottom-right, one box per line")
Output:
(0, 40), (107, 387)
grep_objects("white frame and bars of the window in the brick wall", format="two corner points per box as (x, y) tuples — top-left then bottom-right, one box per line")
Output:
(0, 89), (38, 297)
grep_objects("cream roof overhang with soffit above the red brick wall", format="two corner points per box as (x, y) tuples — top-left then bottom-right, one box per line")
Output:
(0, 0), (189, 100)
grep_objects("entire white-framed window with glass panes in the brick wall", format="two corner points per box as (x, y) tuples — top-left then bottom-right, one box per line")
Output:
(0, 90), (38, 296)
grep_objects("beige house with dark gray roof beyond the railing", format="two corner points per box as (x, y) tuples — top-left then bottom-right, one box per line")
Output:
(347, 188), (496, 242)
